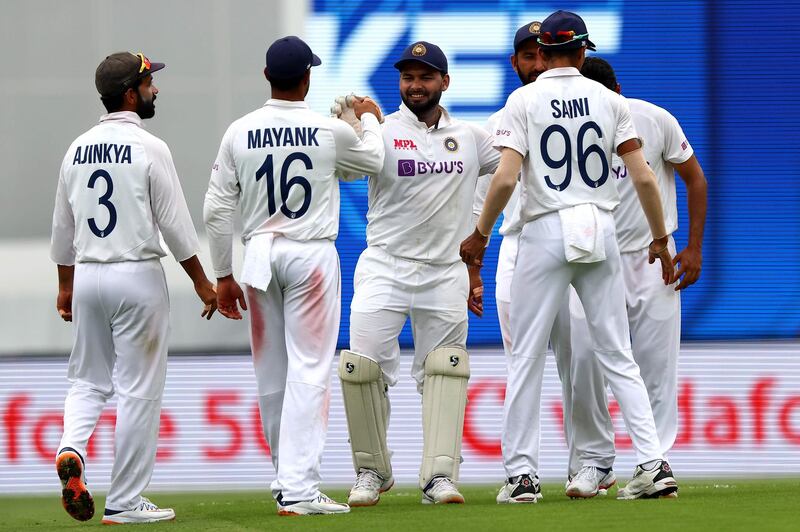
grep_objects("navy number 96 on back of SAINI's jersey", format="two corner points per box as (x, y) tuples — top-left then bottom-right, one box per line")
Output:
(539, 121), (608, 192)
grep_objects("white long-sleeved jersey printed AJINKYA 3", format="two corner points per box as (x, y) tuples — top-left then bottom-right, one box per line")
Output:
(50, 111), (200, 266)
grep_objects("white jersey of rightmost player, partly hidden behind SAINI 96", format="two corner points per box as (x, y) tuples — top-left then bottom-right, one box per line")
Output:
(611, 98), (694, 252)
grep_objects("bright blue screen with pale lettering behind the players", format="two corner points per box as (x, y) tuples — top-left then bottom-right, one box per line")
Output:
(307, 0), (800, 346)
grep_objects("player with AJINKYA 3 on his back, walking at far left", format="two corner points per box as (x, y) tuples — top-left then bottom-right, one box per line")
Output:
(50, 52), (216, 524)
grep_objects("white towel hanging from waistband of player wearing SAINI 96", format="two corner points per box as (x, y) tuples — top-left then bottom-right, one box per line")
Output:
(558, 203), (606, 262)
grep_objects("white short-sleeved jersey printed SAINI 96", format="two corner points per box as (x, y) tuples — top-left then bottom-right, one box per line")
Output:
(495, 67), (637, 223)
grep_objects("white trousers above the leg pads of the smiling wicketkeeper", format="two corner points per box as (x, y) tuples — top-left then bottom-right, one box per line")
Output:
(350, 246), (469, 391)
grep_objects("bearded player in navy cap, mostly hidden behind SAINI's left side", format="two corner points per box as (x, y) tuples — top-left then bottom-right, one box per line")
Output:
(473, 21), (572, 504)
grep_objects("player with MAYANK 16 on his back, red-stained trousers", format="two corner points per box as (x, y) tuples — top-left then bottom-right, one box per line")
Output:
(204, 37), (384, 515)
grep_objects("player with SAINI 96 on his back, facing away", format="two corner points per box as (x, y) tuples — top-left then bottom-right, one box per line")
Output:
(461, 11), (677, 498)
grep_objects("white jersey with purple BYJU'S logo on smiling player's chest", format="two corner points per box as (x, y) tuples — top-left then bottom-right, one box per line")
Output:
(367, 104), (500, 264)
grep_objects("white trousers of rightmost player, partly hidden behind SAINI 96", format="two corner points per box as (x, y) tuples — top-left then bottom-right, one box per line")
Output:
(565, 237), (681, 468)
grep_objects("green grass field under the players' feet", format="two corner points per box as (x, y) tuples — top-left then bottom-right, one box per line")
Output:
(6, 479), (800, 532)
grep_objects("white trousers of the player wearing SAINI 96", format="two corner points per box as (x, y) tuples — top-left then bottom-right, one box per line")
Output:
(502, 211), (662, 477)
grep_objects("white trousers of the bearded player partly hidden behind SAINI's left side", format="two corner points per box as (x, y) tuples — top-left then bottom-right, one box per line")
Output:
(495, 233), (572, 474)
